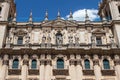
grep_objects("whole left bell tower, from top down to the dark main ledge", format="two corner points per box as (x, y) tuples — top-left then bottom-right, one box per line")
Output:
(0, 0), (16, 48)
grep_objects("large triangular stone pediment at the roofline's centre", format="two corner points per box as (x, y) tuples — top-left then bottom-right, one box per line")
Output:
(41, 19), (78, 27)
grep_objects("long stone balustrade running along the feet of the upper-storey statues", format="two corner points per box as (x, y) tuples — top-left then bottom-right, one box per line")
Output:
(7, 43), (111, 48)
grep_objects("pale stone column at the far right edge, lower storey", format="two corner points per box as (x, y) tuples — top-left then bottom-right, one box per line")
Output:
(114, 55), (120, 80)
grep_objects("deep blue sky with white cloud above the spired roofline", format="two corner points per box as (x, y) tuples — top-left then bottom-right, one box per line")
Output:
(15, 0), (101, 22)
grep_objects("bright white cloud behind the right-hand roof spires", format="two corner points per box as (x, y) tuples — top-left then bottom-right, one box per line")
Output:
(66, 9), (99, 21)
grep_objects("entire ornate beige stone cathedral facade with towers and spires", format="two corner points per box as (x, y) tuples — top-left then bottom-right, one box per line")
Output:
(0, 0), (120, 80)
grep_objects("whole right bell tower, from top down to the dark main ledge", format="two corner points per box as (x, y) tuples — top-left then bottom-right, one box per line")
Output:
(98, 0), (120, 48)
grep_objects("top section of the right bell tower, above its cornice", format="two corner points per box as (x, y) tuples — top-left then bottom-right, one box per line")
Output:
(98, 0), (120, 20)
